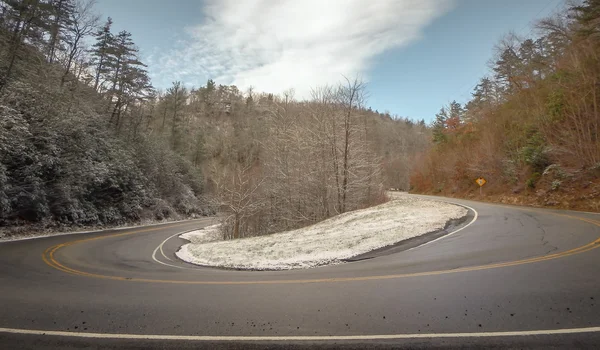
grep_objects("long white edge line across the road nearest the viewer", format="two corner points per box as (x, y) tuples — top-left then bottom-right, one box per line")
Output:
(0, 327), (600, 341)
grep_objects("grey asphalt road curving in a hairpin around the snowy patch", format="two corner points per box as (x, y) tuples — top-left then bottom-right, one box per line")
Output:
(0, 199), (600, 349)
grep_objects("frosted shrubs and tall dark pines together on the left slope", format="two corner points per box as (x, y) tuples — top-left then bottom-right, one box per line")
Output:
(0, 0), (210, 234)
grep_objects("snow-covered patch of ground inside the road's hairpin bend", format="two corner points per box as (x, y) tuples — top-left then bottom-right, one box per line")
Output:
(176, 194), (467, 270)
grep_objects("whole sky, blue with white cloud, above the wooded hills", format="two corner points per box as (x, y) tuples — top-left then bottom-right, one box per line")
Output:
(95, 0), (563, 121)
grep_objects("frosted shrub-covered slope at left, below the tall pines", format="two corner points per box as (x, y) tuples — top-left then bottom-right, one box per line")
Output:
(0, 40), (214, 233)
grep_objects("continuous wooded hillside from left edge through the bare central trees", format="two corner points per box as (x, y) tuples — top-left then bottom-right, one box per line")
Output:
(0, 0), (430, 238)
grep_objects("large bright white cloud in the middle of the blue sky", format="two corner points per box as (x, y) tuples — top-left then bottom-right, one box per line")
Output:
(151, 0), (452, 97)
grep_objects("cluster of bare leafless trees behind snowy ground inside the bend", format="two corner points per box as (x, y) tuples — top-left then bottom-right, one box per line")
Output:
(214, 81), (384, 238)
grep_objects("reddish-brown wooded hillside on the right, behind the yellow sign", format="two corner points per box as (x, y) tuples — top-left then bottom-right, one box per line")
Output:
(411, 0), (600, 210)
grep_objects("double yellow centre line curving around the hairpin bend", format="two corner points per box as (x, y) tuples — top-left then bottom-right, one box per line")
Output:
(42, 213), (600, 285)
